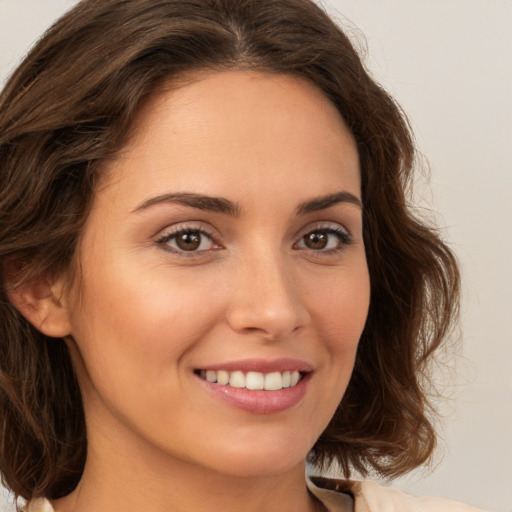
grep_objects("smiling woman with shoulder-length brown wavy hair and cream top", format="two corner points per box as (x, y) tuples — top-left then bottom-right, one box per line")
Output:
(0, 0), (484, 512)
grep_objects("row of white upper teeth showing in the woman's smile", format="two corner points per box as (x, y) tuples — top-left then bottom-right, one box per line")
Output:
(194, 370), (305, 391)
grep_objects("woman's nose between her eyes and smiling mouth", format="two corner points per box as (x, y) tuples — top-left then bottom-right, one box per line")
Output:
(227, 251), (310, 341)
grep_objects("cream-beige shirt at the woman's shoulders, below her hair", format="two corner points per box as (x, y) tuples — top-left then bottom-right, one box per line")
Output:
(22, 477), (483, 512)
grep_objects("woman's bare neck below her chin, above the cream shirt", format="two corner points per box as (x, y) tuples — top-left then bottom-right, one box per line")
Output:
(54, 422), (323, 512)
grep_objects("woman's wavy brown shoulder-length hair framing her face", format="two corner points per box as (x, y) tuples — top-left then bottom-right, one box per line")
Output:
(0, 0), (459, 499)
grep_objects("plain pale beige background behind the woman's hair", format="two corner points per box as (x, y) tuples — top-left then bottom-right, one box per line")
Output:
(0, 0), (512, 512)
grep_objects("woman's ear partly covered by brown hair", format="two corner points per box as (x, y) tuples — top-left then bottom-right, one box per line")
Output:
(8, 276), (71, 338)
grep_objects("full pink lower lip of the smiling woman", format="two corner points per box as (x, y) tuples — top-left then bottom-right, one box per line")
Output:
(197, 373), (311, 414)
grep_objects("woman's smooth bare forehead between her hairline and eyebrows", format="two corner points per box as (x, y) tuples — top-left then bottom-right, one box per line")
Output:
(100, 71), (360, 208)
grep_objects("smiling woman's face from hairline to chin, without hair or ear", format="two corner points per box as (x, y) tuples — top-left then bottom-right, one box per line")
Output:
(64, 71), (369, 476)
